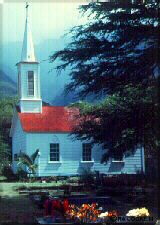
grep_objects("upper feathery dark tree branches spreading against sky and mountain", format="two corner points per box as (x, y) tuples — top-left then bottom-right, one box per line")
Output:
(50, 1), (158, 97)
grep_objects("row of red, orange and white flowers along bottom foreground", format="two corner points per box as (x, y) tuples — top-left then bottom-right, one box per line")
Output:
(35, 194), (155, 225)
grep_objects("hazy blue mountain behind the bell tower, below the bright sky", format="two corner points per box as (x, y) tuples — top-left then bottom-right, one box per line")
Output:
(0, 38), (70, 102)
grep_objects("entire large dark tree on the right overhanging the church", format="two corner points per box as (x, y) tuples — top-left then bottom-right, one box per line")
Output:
(50, 0), (159, 160)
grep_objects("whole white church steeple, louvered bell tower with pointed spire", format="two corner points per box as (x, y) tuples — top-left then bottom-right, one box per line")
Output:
(17, 3), (42, 113)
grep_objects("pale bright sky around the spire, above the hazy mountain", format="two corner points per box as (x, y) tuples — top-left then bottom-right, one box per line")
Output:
(2, 0), (87, 44)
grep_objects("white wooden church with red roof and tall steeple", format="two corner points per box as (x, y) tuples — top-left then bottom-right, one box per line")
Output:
(10, 3), (145, 177)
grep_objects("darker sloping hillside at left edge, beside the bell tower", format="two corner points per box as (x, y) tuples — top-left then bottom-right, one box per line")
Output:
(0, 70), (17, 98)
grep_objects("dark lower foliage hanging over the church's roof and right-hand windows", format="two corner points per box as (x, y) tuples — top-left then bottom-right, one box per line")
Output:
(74, 85), (158, 161)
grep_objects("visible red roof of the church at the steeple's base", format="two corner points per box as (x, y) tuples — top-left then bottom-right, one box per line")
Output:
(18, 106), (78, 132)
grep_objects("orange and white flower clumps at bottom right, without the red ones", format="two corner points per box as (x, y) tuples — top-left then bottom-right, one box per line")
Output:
(66, 203), (154, 224)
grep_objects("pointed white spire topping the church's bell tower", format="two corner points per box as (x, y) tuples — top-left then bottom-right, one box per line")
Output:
(21, 2), (36, 62)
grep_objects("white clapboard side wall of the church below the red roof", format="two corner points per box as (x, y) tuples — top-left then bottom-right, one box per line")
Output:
(26, 133), (142, 176)
